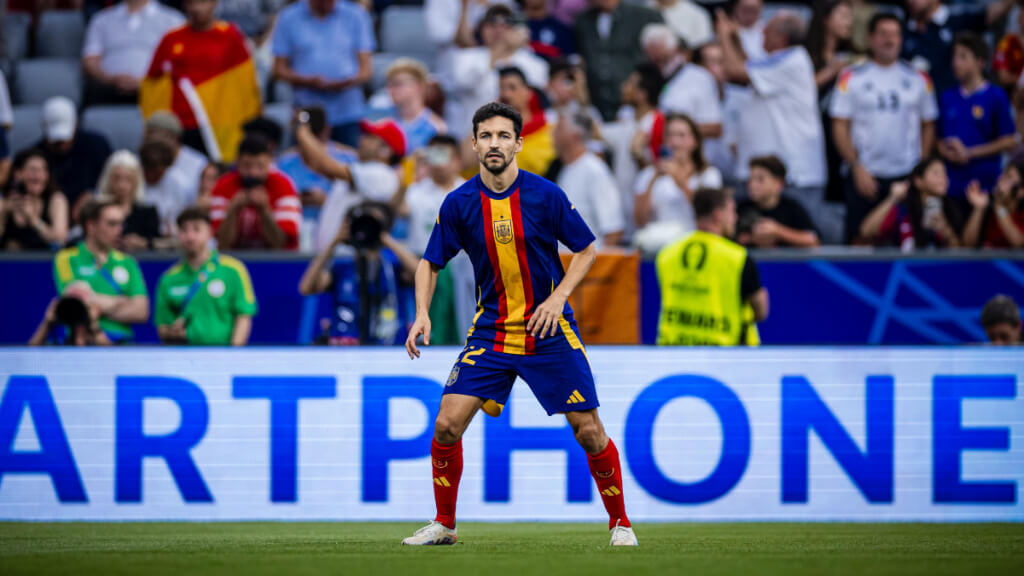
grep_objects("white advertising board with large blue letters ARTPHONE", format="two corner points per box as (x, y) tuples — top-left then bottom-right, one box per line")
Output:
(0, 347), (1024, 522)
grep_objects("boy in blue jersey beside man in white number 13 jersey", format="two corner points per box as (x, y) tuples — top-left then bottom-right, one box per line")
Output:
(937, 32), (1017, 201)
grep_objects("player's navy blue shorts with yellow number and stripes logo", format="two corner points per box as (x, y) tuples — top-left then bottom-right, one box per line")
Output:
(444, 336), (598, 416)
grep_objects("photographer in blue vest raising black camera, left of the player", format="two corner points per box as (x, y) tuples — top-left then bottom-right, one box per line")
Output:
(299, 201), (419, 345)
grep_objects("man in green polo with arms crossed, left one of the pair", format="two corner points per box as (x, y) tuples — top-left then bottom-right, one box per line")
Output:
(53, 199), (150, 342)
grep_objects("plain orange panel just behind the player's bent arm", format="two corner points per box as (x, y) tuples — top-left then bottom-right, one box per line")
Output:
(562, 251), (640, 344)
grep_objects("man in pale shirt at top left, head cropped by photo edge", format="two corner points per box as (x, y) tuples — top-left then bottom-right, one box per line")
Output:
(82, 0), (185, 106)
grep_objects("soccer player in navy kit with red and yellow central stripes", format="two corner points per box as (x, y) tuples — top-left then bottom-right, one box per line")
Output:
(402, 102), (637, 546)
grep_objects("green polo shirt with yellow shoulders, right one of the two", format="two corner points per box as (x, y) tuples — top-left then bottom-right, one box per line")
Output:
(156, 251), (256, 345)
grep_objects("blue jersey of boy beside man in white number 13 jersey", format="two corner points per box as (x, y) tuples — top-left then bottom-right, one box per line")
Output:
(939, 82), (1017, 198)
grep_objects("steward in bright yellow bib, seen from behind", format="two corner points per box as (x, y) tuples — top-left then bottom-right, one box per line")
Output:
(655, 189), (768, 346)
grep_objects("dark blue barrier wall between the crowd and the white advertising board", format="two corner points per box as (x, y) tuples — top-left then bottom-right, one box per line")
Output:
(0, 250), (1024, 345)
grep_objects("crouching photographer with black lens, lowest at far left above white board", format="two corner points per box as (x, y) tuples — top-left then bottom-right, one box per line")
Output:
(29, 285), (111, 346)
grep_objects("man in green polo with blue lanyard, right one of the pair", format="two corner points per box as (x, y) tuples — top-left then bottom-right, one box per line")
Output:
(154, 206), (256, 346)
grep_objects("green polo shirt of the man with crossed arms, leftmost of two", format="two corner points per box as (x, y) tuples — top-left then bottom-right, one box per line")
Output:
(53, 242), (147, 341)
